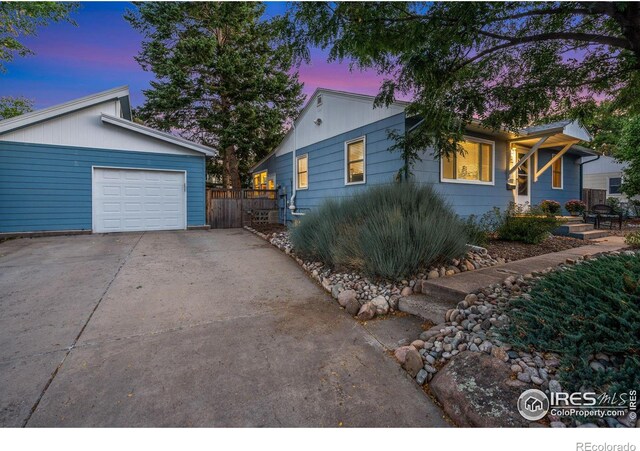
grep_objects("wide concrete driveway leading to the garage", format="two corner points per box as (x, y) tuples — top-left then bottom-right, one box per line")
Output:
(0, 230), (446, 427)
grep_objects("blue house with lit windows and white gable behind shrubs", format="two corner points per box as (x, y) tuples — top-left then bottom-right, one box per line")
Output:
(251, 89), (595, 221)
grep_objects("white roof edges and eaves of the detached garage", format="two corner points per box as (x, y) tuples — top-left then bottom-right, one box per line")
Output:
(0, 86), (216, 156)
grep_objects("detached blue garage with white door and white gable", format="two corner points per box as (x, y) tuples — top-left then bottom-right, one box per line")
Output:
(0, 87), (213, 234)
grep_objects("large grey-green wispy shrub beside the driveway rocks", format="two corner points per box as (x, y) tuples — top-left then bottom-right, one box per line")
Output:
(290, 183), (469, 279)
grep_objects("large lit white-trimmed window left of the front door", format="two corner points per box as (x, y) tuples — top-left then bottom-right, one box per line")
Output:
(440, 136), (495, 185)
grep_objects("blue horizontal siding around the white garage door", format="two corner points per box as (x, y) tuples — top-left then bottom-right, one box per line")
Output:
(0, 142), (205, 232)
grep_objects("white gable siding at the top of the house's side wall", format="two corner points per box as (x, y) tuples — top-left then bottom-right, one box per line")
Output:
(276, 91), (404, 156)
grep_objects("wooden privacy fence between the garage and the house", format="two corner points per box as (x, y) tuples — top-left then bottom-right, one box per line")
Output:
(206, 188), (278, 229)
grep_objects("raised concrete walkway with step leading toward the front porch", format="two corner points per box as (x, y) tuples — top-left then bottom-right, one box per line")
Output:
(400, 236), (627, 323)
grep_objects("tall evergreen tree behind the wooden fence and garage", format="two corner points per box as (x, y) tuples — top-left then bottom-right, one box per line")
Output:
(126, 2), (303, 188)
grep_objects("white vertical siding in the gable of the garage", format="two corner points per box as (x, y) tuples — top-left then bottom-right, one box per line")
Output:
(0, 100), (202, 155)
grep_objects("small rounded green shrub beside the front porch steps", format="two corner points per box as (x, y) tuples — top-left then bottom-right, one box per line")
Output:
(497, 203), (562, 244)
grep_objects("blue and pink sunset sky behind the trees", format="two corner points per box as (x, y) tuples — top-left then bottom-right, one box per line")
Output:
(0, 2), (381, 108)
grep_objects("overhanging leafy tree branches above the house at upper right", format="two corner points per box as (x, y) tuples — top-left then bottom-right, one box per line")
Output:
(289, 2), (640, 177)
